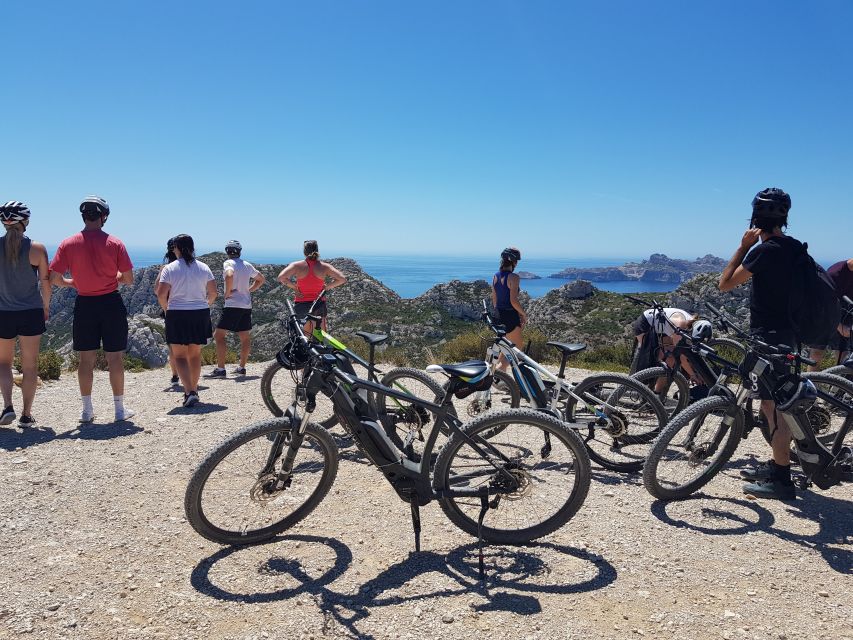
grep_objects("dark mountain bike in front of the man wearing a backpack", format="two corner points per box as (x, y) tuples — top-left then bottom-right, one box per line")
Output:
(643, 305), (853, 500)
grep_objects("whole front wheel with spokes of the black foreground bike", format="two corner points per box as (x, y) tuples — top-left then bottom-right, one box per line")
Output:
(184, 417), (338, 545)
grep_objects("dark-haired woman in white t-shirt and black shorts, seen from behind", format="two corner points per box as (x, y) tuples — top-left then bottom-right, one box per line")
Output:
(156, 234), (217, 407)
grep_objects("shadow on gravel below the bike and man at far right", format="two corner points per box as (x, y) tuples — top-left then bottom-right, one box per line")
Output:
(651, 491), (853, 575)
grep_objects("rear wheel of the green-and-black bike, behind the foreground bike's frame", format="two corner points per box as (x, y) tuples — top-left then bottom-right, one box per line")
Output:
(373, 367), (444, 450)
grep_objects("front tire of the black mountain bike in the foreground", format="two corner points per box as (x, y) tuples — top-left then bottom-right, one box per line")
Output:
(184, 417), (339, 545)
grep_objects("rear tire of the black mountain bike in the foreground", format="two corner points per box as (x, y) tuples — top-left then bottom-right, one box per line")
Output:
(433, 409), (591, 544)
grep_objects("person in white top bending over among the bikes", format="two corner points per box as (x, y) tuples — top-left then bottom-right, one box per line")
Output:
(631, 307), (696, 394)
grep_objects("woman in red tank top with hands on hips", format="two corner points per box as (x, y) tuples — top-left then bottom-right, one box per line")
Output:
(278, 240), (347, 336)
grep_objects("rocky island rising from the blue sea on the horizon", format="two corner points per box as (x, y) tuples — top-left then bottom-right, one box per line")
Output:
(551, 253), (726, 284)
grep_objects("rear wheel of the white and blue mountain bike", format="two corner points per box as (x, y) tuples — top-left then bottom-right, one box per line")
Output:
(564, 373), (667, 472)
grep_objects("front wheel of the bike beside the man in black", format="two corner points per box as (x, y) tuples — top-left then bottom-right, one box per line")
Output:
(643, 396), (743, 500)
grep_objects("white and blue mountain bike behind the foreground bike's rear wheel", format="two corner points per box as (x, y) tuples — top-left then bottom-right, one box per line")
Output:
(452, 300), (666, 472)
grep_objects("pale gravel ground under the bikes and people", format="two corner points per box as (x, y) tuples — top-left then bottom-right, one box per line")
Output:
(0, 364), (853, 640)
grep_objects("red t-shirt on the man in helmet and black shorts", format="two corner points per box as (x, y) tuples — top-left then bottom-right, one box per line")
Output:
(50, 230), (133, 296)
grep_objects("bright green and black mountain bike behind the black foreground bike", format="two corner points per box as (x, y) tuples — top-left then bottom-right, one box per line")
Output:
(261, 291), (443, 429)
